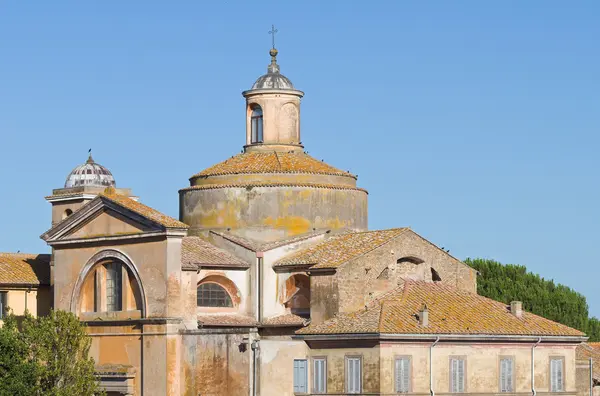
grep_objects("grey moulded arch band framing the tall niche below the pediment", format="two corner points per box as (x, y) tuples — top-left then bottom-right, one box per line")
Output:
(70, 249), (147, 318)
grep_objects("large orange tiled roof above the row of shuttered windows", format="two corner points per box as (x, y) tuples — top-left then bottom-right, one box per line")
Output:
(297, 281), (584, 337)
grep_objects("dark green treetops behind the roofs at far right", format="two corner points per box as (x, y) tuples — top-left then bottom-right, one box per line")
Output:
(465, 259), (600, 341)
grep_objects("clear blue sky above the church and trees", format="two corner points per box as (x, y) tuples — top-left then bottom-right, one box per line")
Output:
(0, 0), (600, 316)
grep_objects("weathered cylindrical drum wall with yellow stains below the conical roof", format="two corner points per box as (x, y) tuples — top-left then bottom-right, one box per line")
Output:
(180, 186), (367, 241)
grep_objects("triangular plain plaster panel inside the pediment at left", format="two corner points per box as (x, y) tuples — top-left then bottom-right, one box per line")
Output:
(64, 208), (158, 239)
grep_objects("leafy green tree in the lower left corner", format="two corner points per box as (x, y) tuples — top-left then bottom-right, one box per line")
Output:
(0, 311), (101, 396)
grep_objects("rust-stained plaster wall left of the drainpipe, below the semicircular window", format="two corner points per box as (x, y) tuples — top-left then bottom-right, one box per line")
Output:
(181, 330), (252, 396)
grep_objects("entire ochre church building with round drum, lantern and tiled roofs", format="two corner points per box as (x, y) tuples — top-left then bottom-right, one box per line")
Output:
(0, 44), (595, 396)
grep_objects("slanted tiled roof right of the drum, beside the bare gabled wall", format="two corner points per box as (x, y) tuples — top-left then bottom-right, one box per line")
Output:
(274, 228), (408, 268)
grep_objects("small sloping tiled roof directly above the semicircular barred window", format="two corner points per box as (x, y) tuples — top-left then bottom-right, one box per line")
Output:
(181, 236), (250, 268)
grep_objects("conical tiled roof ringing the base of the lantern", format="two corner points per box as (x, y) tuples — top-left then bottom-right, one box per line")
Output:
(191, 151), (356, 179)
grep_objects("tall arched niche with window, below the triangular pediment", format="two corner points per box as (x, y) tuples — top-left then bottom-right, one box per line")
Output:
(71, 249), (147, 318)
